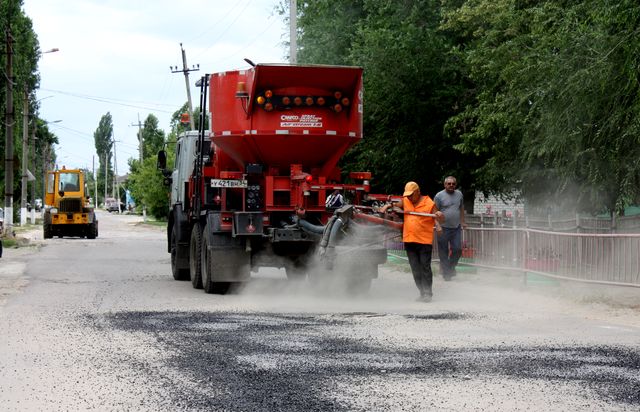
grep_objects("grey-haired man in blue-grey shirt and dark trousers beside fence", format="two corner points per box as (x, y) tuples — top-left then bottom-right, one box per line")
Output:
(433, 176), (466, 280)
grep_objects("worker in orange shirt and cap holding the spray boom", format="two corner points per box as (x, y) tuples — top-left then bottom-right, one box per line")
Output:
(380, 182), (444, 302)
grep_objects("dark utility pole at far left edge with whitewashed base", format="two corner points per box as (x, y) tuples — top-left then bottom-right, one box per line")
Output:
(4, 27), (14, 234)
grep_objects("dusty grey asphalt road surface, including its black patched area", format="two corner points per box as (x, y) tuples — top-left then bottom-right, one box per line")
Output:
(0, 213), (640, 411)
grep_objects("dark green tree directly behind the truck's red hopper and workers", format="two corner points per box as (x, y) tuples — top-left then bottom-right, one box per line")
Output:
(299, 0), (471, 194)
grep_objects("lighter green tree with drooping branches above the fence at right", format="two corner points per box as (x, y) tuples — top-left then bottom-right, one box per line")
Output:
(442, 0), (640, 216)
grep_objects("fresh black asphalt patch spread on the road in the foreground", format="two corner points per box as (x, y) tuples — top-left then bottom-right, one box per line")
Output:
(92, 312), (640, 411)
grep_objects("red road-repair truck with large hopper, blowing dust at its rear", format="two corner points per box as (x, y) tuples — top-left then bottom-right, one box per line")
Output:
(158, 64), (387, 293)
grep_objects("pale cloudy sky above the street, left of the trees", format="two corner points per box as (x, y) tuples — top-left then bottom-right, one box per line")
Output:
(23, 0), (289, 175)
